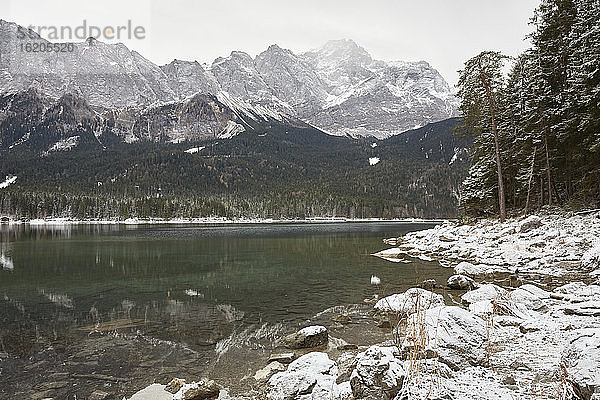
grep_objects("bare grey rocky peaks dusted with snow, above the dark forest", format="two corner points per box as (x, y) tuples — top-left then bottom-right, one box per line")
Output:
(0, 20), (457, 140)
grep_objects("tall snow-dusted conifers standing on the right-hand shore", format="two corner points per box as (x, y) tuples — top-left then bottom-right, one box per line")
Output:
(459, 0), (600, 219)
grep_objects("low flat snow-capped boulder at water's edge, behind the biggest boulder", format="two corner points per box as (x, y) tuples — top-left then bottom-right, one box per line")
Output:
(375, 288), (445, 314)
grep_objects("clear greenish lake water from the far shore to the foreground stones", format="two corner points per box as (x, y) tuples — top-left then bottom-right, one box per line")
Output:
(0, 223), (452, 399)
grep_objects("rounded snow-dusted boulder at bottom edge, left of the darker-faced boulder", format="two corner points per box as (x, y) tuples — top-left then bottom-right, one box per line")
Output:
(267, 352), (338, 400)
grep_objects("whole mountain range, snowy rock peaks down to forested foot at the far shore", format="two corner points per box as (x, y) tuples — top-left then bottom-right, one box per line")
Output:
(0, 21), (470, 219)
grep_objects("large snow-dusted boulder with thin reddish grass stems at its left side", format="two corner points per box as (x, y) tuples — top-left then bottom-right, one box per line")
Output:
(402, 306), (487, 370)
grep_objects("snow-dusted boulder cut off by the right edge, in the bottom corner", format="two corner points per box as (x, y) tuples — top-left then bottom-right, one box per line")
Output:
(561, 328), (600, 399)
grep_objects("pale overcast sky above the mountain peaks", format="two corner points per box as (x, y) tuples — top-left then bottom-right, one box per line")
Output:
(0, 0), (539, 85)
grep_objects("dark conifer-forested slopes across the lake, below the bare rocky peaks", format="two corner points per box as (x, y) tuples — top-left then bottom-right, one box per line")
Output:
(0, 119), (469, 219)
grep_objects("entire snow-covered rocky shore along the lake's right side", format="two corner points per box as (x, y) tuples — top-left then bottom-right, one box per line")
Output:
(126, 213), (600, 400)
